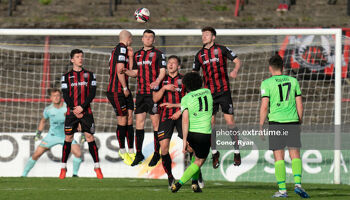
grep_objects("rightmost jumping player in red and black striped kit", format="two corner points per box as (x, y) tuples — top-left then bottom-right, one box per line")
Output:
(192, 27), (241, 169)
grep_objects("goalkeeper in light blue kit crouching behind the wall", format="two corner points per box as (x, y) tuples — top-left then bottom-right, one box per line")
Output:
(22, 89), (82, 177)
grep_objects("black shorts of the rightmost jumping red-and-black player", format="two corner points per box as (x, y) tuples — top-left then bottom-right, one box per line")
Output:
(213, 91), (233, 115)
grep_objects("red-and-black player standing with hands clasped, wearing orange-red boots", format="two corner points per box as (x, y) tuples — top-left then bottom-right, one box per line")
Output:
(59, 49), (103, 179)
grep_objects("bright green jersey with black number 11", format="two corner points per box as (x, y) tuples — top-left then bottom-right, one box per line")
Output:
(181, 88), (213, 134)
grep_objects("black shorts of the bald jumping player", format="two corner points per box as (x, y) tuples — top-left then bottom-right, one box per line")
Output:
(107, 92), (130, 116)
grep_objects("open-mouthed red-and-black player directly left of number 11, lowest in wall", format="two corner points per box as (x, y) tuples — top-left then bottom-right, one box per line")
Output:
(153, 55), (185, 188)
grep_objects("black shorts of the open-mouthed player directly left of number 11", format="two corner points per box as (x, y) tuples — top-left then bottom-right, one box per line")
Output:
(158, 117), (182, 141)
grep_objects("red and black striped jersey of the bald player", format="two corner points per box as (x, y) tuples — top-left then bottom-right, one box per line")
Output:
(107, 43), (129, 93)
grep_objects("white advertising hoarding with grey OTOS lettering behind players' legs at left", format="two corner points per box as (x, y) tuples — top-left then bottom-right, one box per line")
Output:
(0, 133), (184, 179)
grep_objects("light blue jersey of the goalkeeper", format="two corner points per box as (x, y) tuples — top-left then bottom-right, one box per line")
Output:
(43, 103), (67, 137)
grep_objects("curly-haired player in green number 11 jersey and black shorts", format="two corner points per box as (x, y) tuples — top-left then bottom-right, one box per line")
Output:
(171, 72), (213, 192)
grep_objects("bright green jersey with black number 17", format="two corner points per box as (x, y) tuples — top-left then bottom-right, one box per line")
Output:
(261, 75), (301, 123)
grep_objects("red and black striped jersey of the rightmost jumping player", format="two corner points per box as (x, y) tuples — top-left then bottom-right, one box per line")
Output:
(192, 43), (237, 94)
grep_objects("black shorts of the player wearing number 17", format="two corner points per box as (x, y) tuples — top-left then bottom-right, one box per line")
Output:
(269, 122), (301, 150)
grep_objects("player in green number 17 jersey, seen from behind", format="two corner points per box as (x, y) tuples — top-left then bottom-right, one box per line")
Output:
(260, 55), (309, 198)
